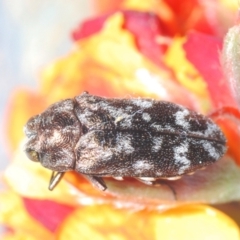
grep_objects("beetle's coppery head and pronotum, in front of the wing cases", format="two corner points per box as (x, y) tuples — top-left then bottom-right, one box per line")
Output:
(24, 99), (81, 172)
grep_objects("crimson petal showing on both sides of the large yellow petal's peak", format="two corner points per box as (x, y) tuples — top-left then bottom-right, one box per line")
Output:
(72, 11), (163, 66)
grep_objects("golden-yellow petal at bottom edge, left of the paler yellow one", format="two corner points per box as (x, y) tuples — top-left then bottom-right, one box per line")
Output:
(57, 205), (150, 240)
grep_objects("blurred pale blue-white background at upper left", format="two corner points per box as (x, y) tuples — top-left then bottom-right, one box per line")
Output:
(0, 0), (92, 171)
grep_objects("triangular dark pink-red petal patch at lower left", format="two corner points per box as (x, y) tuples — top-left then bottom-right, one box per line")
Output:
(23, 198), (74, 232)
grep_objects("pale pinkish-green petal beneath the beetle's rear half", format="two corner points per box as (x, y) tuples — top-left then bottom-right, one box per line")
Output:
(105, 156), (240, 205)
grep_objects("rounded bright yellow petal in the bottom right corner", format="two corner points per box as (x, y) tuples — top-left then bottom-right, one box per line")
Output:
(156, 205), (240, 240)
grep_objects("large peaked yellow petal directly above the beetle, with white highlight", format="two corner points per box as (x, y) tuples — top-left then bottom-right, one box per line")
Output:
(41, 13), (197, 107)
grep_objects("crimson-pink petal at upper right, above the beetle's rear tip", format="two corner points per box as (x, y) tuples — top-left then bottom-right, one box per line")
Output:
(184, 32), (236, 108)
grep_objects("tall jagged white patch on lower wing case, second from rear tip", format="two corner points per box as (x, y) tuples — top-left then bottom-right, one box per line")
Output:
(174, 141), (191, 174)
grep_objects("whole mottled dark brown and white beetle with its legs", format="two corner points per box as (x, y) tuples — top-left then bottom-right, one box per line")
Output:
(25, 93), (226, 190)
